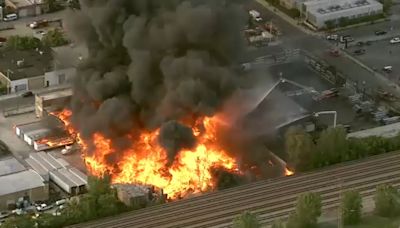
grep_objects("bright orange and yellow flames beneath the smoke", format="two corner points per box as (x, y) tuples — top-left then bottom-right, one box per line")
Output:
(53, 110), (293, 199)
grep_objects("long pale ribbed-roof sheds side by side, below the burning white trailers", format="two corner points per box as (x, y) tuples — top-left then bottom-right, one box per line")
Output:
(25, 151), (87, 195)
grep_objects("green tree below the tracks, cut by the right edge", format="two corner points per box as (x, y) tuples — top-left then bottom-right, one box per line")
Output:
(374, 184), (400, 217)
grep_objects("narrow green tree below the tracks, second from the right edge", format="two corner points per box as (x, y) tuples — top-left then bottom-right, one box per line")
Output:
(341, 191), (362, 225)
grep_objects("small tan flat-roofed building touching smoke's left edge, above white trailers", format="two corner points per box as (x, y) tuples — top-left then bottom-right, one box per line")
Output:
(35, 88), (72, 118)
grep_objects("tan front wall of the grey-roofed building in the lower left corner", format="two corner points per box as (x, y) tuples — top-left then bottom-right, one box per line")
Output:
(0, 184), (49, 210)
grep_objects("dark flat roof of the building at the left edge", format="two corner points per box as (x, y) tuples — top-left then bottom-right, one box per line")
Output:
(0, 46), (54, 81)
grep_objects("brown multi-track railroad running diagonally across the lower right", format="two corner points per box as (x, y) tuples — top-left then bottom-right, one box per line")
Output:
(72, 152), (400, 228)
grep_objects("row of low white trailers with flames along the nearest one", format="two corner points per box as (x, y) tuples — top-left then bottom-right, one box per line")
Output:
(15, 116), (75, 151)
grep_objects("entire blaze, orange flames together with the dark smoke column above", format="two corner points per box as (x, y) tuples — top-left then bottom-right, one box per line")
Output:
(59, 0), (292, 198)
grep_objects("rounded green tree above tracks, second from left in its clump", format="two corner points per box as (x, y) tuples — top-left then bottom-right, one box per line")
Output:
(316, 127), (349, 167)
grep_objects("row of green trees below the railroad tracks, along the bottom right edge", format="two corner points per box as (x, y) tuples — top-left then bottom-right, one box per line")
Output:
(233, 184), (400, 228)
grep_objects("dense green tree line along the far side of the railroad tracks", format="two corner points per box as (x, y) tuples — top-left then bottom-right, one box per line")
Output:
(285, 127), (400, 172)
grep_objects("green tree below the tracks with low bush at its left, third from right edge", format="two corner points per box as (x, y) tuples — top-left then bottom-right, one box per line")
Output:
(286, 192), (322, 228)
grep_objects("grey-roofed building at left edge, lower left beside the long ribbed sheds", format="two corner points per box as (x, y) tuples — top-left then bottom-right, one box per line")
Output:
(0, 158), (49, 210)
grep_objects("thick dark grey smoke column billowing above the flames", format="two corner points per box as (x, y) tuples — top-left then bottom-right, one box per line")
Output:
(67, 0), (246, 164)
